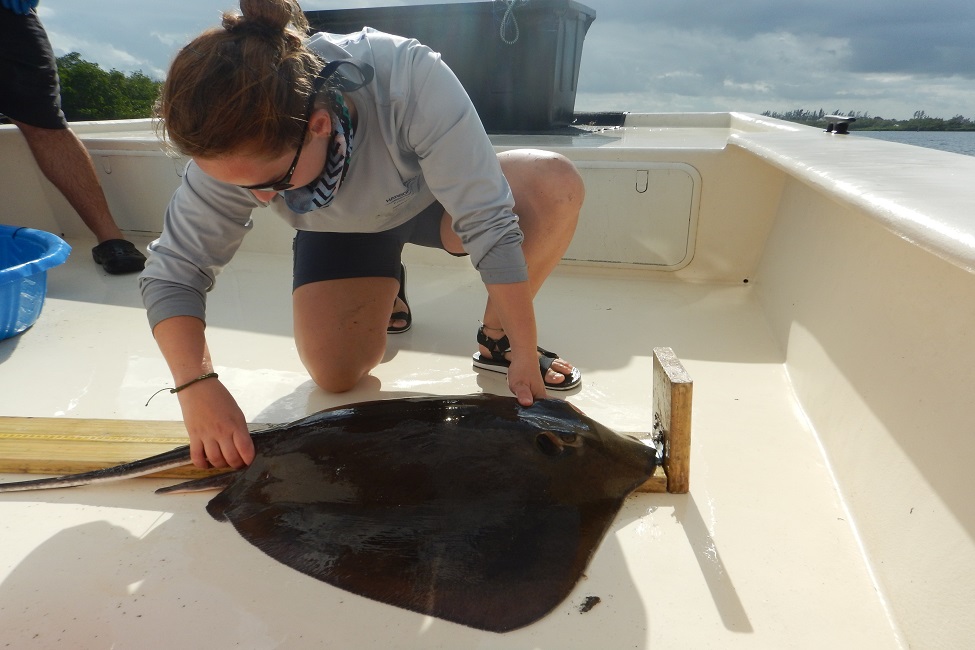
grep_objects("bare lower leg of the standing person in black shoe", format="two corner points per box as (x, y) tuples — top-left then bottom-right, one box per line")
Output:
(14, 121), (123, 243)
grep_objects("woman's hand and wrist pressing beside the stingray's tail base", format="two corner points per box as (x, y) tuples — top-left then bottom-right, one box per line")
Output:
(179, 378), (254, 469)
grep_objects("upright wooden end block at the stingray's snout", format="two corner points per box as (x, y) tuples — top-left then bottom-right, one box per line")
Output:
(653, 348), (694, 494)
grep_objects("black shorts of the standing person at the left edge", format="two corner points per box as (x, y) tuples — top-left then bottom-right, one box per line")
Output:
(0, 9), (68, 129)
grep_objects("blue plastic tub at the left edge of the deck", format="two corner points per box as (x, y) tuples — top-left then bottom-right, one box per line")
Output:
(0, 225), (71, 340)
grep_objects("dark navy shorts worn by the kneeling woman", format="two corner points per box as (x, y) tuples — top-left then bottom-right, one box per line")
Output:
(293, 201), (463, 289)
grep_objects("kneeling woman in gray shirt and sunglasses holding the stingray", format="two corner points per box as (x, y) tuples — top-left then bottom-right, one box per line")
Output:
(140, 0), (584, 467)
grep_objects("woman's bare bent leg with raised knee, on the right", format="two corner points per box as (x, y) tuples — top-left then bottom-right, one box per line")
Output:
(441, 149), (585, 384)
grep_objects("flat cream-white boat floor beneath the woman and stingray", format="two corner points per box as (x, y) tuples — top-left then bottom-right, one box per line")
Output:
(0, 240), (896, 648)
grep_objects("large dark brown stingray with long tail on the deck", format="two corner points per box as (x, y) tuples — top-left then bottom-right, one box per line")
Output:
(0, 395), (660, 632)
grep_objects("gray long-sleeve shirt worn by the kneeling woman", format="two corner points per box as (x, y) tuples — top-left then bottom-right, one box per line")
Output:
(140, 27), (528, 327)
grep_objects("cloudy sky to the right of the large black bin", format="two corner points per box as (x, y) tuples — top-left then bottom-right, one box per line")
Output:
(576, 0), (975, 118)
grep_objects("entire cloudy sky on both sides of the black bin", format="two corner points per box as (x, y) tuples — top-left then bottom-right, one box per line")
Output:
(39, 0), (975, 119)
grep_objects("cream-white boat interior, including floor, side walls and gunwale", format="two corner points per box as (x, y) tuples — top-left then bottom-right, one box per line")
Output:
(0, 114), (975, 650)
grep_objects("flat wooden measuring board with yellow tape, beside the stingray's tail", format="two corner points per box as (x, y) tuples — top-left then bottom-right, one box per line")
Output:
(0, 417), (215, 478)
